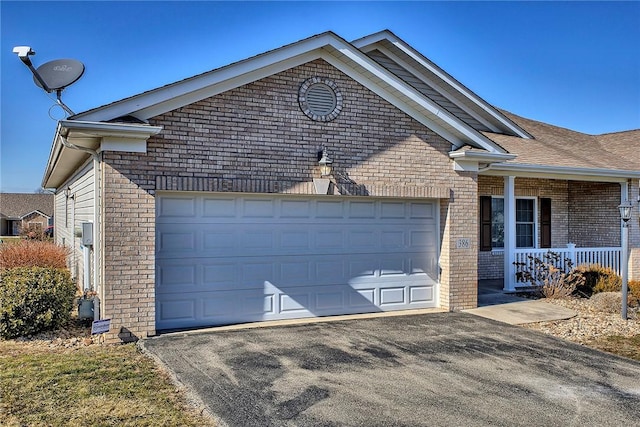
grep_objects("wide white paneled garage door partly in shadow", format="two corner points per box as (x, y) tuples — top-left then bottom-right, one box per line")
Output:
(156, 193), (438, 330)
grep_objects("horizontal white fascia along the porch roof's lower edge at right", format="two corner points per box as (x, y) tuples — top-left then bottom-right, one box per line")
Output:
(480, 163), (640, 182)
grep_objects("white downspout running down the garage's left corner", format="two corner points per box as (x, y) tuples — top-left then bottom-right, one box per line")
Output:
(59, 135), (102, 320)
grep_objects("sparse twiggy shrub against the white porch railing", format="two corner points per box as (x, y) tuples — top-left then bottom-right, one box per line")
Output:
(514, 251), (584, 298)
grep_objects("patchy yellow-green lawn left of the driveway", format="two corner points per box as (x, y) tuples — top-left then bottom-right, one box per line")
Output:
(0, 341), (212, 426)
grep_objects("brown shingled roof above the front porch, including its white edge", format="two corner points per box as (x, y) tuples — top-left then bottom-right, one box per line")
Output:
(483, 111), (640, 179)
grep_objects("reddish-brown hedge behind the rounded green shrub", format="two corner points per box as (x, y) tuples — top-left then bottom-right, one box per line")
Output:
(0, 240), (69, 268)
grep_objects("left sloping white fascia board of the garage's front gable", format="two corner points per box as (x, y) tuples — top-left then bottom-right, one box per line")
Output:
(74, 33), (337, 121)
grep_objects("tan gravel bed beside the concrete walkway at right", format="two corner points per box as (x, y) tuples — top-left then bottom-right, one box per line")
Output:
(522, 292), (640, 345)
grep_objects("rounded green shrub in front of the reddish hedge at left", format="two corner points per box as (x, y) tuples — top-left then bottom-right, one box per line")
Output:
(0, 267), (76, 338)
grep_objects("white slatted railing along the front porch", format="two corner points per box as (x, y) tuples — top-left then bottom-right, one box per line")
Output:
(515, 244), (622, 282)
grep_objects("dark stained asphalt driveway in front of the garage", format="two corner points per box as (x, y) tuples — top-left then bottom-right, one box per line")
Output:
(143, 313), (640, 427)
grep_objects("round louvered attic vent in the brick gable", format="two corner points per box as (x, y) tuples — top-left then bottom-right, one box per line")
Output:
(298, 77), (342, 122)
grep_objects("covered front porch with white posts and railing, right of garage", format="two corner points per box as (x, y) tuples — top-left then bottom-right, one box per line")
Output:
(478, 171), (640, 290)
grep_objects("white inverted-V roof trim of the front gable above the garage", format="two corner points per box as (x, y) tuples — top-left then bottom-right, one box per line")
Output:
(70, 32), (502, 153)
